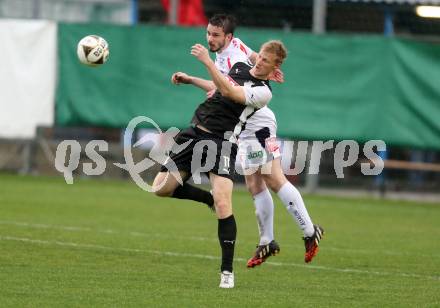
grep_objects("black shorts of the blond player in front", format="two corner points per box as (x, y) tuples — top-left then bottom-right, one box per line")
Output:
(160, 127), (237, 180)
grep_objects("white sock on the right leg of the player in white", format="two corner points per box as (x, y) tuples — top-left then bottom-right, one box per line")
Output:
(278, 182), (315, 236)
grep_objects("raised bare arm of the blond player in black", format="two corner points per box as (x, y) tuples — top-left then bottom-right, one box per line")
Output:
(191, 44), (246, 104)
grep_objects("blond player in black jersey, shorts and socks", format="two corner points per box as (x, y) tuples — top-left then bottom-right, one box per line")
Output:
(153, 41), (287, 288)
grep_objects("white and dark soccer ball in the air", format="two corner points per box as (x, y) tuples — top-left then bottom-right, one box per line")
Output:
(76, 35), (110, 66)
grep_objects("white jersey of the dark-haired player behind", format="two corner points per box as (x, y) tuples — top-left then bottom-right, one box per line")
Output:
(215, 37), (277, 139)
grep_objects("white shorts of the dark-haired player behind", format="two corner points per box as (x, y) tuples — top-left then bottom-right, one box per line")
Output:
(237, 136), (281, 170)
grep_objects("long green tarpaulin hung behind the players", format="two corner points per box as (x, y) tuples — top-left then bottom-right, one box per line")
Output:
(56, 24), (440, 149)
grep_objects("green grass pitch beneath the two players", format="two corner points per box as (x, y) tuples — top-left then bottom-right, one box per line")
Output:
(0, 175), (440, 307)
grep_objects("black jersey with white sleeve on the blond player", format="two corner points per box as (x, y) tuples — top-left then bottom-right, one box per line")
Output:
(191, 62), (272, 142)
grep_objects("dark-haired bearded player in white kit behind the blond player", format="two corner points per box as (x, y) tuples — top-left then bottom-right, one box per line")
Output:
(171, 14), (324, 268)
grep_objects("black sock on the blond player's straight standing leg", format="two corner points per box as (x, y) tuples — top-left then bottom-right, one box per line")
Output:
(218, 215), (237, 273)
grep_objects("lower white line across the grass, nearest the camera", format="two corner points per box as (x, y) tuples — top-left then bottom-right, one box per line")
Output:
(0, 235), (440, 280)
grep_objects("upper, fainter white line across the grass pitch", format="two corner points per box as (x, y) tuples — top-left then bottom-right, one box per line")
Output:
(0, 220), (440, 258)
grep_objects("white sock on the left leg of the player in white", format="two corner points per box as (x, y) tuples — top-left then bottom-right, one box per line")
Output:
(254, 188), (273, 245)
